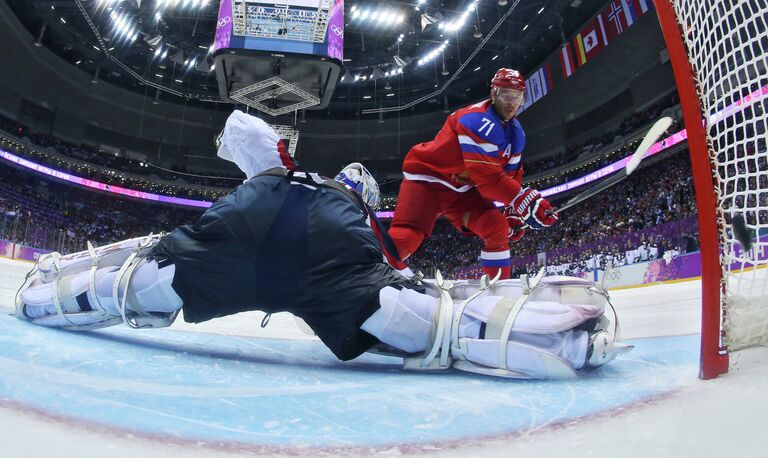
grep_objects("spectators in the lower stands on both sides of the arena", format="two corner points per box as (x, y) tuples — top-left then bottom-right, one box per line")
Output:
(0, 144), (698, 278)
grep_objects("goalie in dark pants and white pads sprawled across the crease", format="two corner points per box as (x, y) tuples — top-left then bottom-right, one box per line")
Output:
(16, 111), (626, 378)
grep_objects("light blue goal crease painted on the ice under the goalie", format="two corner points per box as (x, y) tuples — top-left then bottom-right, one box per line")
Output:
(0, 314), (699, 453)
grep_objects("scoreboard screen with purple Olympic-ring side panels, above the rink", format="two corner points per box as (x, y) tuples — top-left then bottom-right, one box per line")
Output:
(214, 0), (344, 61)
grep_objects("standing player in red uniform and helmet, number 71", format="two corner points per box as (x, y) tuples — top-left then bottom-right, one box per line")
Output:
(389, 68), (557, 279)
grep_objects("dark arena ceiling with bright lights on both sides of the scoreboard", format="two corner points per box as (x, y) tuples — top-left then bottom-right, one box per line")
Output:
(5, 0), (606, 118)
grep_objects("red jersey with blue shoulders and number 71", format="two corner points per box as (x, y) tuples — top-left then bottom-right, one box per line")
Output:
(403, 100), (525, 204)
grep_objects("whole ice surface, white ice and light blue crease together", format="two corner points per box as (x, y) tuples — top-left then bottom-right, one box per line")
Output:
(0, 259), (768, 457)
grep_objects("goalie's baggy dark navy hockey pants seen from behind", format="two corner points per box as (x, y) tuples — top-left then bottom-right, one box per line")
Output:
(153, 170), (407, 360)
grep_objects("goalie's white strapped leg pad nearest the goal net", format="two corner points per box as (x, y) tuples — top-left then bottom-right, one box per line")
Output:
(452, 272), (632, 378)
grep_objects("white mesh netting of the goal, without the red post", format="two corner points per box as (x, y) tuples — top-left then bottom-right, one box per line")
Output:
(672, 0), (768, 351)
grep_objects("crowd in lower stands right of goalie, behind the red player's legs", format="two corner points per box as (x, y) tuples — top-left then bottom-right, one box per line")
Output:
(409, 151), (698, 278)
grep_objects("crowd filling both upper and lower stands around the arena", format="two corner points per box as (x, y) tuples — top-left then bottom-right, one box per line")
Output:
(0, 87), (698, 278)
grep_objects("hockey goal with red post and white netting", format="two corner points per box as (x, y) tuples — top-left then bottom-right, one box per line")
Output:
(654, 0), (768, 378)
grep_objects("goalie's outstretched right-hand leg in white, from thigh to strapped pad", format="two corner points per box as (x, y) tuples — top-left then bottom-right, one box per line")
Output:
(362, 277), (610, 378)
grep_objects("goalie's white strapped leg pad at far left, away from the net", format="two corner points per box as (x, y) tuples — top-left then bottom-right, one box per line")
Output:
(16, 234), (182, 330)
